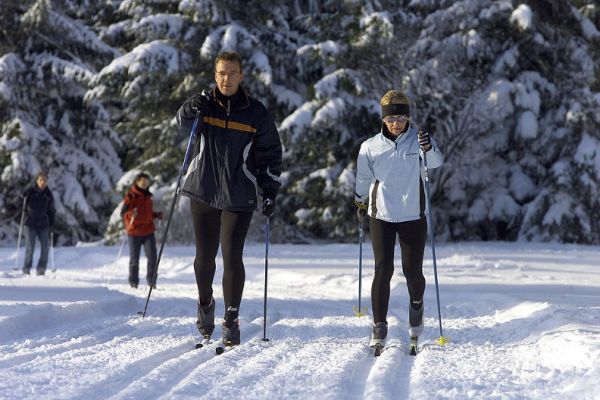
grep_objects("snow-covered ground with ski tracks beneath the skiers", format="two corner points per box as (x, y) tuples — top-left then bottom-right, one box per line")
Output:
(0, 239), (600, 400)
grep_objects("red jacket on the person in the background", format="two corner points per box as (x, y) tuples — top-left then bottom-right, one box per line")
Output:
(121, 184), (162, 236)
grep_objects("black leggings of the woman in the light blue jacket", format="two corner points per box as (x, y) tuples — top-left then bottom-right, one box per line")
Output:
(369, 218), (427, 323)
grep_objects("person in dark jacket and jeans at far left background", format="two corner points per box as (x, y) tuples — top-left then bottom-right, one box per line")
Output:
(23, 172), (56, 275)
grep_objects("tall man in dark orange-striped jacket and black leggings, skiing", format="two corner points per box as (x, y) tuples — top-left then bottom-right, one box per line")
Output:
(177, 52), (282, 346)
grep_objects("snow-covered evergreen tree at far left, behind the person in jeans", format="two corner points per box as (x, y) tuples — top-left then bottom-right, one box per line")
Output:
(0, 0), (121, 243)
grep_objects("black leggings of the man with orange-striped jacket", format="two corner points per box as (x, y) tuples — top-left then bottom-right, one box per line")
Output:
(190, 200), (252, 318)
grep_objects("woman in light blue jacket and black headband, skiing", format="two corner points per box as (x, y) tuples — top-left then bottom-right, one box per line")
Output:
(355, 90), (443, 347)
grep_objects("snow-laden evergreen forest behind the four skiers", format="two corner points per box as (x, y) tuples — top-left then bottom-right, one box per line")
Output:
(0, 0), (600, 245)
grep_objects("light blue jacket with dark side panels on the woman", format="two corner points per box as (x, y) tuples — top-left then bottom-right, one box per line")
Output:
(355, 126), (444, 222)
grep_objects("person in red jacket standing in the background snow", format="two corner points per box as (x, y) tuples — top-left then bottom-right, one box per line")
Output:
(121, 173), (162, 288)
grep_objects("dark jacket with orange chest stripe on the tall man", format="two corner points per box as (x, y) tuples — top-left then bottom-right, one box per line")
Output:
(177, 87), (282, 211)
